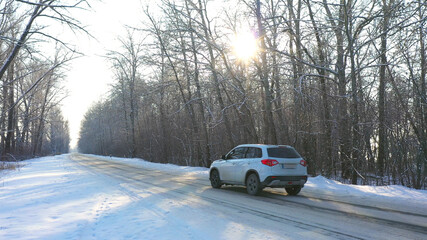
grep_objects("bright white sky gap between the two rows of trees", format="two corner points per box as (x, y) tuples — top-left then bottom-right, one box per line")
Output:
(61, 0), (142, 148)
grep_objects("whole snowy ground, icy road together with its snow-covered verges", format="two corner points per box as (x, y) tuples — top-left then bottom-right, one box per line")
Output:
(0, 154), (427, 240)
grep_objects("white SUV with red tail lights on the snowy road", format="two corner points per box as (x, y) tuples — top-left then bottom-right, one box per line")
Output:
(209, 144), (307, 195)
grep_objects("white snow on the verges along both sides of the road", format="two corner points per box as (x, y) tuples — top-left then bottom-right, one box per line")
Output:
(0, 155), (427, 239)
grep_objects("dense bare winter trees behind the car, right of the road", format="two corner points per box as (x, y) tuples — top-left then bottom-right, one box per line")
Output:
(79, 0), (427, 188)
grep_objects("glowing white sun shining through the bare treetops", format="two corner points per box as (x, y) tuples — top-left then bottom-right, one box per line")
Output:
(232, 31), (258, 61)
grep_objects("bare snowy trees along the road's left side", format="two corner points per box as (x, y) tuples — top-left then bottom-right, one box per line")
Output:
(0, 0), (88, 160)
